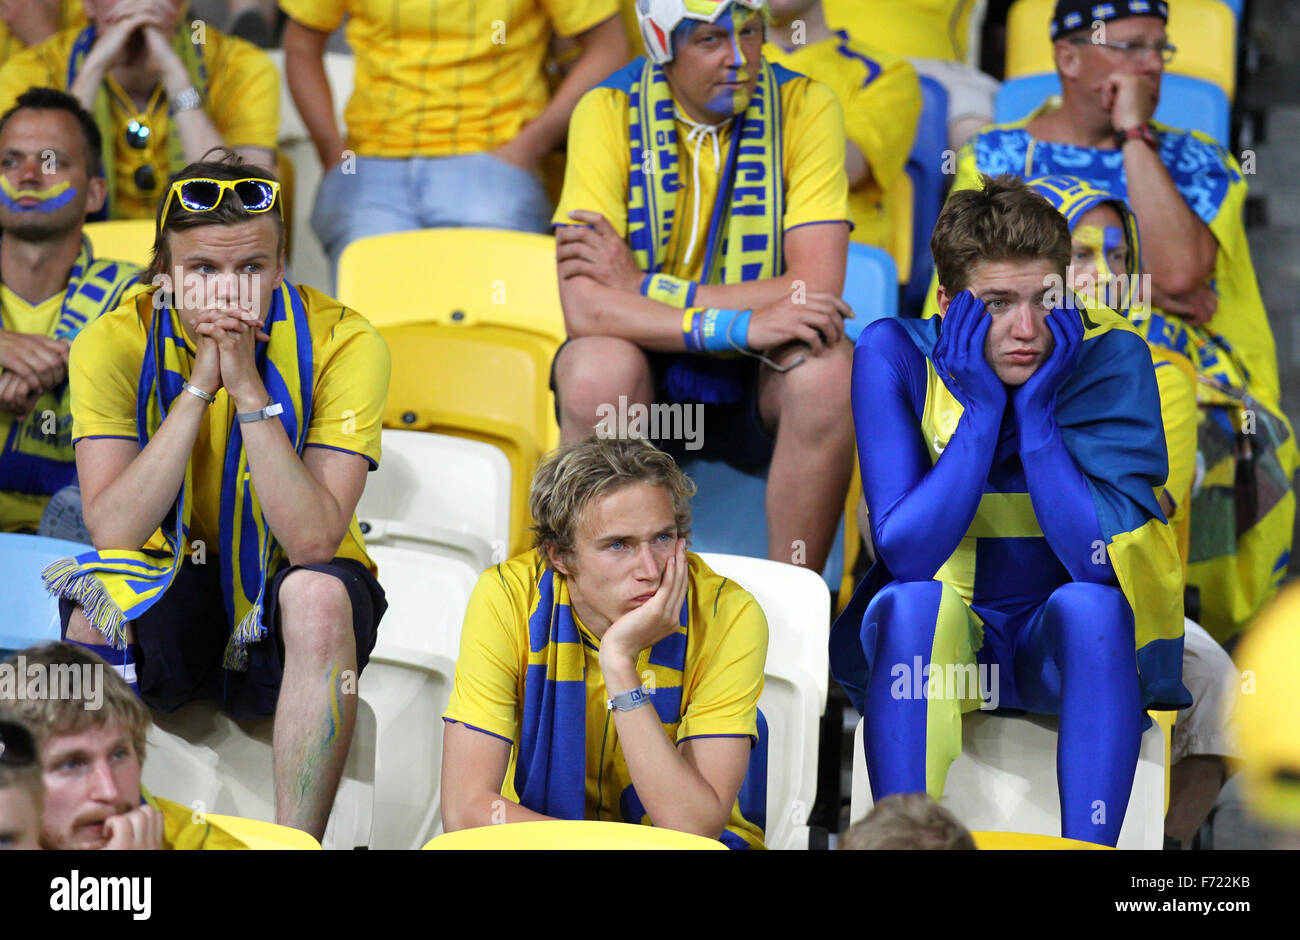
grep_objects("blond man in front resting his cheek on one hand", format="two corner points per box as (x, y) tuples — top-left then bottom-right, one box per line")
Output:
(442, 437), (767, 849)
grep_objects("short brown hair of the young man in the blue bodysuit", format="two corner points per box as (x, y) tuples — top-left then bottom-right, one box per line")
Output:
(930, 176), (1070, 296)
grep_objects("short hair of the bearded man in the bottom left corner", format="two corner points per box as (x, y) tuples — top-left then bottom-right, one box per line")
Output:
(0, 642), (152, 764)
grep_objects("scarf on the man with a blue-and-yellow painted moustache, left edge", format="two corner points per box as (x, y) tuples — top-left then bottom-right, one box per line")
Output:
(0, 235), (139, 495)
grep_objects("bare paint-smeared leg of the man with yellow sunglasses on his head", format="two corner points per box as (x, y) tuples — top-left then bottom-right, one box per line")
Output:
(272, 569), (356, 839)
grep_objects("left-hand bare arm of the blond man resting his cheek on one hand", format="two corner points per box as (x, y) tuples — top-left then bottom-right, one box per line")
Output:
(442, 722), (551, 832)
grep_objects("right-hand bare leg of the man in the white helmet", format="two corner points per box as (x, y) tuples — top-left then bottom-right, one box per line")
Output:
(759, 343), (854, 572)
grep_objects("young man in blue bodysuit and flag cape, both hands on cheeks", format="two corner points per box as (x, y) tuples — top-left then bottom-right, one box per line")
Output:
(831, 177), (1190, 845)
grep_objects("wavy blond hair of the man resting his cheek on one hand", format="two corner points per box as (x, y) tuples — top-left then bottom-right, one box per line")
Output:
(528, 436), (696, 566)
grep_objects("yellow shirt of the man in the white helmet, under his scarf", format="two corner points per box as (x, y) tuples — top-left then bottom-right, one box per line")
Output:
(551, 66), (849, 281)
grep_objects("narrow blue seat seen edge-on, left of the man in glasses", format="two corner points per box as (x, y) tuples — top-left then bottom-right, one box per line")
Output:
(902, 75), (950, 315)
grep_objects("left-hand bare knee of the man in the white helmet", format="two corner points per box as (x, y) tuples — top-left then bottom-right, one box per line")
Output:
(555, 337), (654, 443)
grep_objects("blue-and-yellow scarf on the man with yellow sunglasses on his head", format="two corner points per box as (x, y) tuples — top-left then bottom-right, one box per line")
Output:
(43, 281), (312, 670)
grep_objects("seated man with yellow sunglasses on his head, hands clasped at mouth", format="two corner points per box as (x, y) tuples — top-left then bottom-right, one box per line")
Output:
(44, 153), (389, 839)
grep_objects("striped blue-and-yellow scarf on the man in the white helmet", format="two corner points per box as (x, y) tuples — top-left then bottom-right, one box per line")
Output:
(628, 60), (793, 283)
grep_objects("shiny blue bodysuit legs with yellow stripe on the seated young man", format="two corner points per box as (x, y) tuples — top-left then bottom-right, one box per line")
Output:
(862, 581), (1143, 845)
